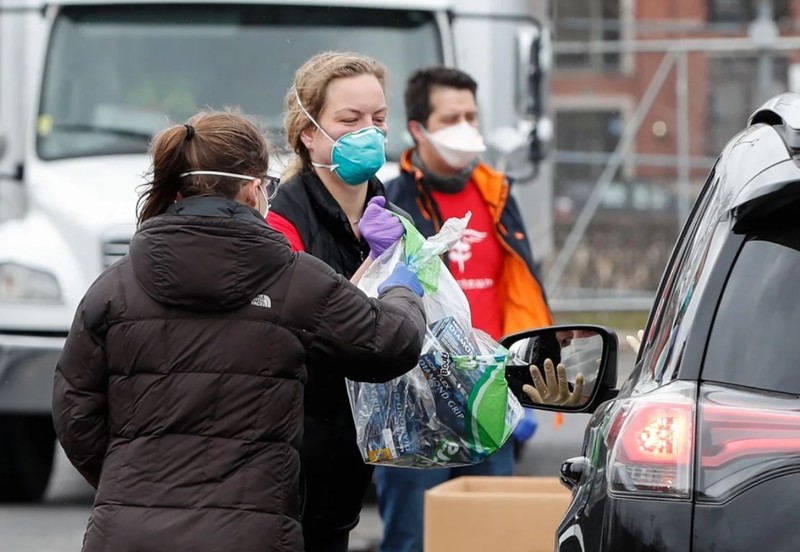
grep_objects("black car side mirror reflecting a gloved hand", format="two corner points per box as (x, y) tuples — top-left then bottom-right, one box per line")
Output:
(500, 325), (619, 412)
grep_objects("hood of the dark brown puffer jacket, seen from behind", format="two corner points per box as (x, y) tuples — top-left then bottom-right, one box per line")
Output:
(130, 196), (294, 311)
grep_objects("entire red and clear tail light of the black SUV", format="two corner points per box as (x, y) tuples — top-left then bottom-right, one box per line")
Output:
(605, 381), (800, 502)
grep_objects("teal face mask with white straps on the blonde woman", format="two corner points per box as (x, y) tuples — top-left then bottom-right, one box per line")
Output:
(294, 90), (386, 186)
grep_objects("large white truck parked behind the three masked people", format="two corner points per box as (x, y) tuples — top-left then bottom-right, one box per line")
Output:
(0, 0), (550, 501)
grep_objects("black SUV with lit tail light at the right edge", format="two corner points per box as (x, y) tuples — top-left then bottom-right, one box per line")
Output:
(510, 94), (800, 552)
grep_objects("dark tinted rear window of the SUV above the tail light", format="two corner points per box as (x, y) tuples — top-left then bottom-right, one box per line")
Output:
(703, 208), (800, 395)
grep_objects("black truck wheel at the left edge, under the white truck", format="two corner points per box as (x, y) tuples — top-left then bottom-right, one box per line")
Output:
(0, 414), (56, 502)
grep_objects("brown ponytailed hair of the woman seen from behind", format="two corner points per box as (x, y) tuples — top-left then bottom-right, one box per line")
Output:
(137, 110), (269, 224)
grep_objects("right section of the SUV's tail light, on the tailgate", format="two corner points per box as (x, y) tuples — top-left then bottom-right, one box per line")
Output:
(696, 385), (800, 502)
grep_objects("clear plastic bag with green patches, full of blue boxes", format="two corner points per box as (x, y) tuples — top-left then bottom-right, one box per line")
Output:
(347, 215), (523, 468)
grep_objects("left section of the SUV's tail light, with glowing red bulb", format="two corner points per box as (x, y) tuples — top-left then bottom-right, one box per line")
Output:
(606, 382), (697, 498)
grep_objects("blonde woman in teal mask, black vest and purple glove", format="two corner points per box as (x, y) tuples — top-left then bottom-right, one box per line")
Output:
(267, 52), (410, 552)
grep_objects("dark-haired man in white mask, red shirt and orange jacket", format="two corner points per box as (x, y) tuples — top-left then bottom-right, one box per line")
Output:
(375, 67), (553, 552)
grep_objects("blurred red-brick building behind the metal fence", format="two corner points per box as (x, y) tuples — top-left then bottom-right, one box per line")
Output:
(544, 0), (800, 297)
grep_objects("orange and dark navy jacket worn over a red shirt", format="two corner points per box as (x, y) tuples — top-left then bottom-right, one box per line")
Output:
(386, 150), (553, 335)
